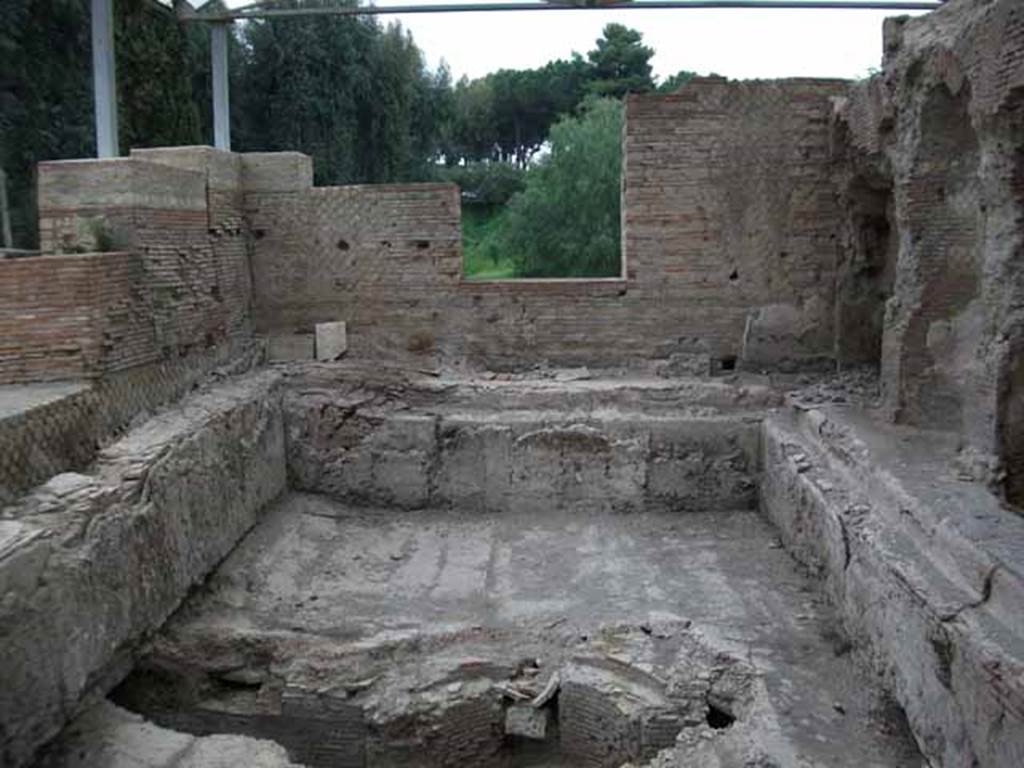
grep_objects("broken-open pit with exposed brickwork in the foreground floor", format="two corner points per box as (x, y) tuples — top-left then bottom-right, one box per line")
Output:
(111, 622), (756, 768)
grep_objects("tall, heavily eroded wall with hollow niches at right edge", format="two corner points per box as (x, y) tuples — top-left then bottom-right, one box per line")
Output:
(839, 0), (1024, 499)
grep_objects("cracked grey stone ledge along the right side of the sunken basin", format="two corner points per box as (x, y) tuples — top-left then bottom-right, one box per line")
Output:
(761, 412), (1024, 768)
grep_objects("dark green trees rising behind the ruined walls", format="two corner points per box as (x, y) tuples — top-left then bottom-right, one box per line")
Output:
(0, 0), (690, 275)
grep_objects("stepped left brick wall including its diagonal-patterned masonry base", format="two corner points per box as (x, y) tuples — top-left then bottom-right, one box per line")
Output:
(0, 147), (255, 505)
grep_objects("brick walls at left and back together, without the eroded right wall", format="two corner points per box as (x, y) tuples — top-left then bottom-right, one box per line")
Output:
(0, 78), (844, 391)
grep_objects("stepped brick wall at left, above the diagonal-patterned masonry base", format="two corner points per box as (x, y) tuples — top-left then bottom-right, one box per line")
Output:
(0, 147), (252, 383)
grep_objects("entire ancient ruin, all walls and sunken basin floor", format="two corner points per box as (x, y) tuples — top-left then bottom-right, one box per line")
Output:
(0, 0), (1024, 768)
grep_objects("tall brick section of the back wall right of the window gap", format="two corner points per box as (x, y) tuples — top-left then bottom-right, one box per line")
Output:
(623, 78), (847, 368)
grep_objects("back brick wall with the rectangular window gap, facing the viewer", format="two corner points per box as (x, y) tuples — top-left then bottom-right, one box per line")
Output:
(246, 79), (845, 371)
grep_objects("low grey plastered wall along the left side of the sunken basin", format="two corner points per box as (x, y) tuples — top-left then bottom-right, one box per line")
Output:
(0, 374), (285, 765)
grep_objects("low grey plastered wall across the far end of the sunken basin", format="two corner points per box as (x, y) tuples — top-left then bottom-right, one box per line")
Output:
(284, 376), (760, 513)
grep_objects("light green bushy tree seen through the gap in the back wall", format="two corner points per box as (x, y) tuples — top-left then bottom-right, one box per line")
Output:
(481, 98), (623, 278)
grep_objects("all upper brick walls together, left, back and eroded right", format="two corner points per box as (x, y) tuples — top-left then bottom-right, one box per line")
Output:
(0, 9), (1024, 495)
